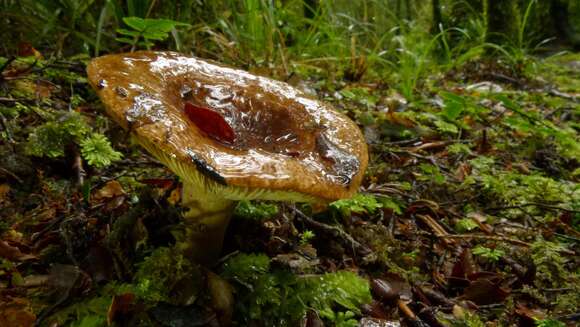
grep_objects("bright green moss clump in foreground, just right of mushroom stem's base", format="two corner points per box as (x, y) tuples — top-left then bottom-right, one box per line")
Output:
(221, 254), (371, 326)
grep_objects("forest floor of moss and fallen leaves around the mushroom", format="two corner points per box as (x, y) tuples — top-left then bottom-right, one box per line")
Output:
(0, 50), (580, 327)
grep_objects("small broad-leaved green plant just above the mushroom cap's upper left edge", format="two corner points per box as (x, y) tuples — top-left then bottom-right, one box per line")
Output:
(116, 17), (189, 52)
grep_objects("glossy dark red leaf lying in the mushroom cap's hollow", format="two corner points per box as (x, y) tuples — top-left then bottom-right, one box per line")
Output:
(185, 103), (236, 144)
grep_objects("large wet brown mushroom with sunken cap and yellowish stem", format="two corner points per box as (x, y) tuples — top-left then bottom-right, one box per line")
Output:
(87, 51), (368, 263)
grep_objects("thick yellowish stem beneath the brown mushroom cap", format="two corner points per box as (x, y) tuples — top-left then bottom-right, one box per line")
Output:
(177, 182), (235, 264)
